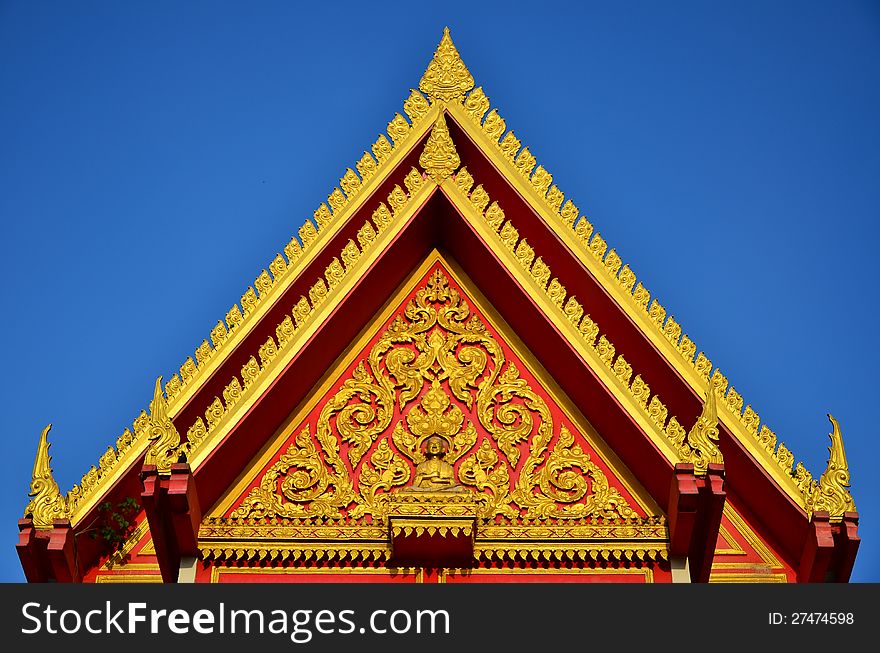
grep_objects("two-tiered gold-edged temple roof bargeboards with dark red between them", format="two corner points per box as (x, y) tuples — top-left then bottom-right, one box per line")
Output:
(28, 29), (855, 560)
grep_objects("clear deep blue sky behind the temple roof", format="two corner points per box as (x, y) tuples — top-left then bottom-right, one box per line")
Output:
(0, 0), (880, 581)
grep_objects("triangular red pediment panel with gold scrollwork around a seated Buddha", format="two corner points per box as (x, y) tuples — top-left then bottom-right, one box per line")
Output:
(231, 269), (640, 523)
